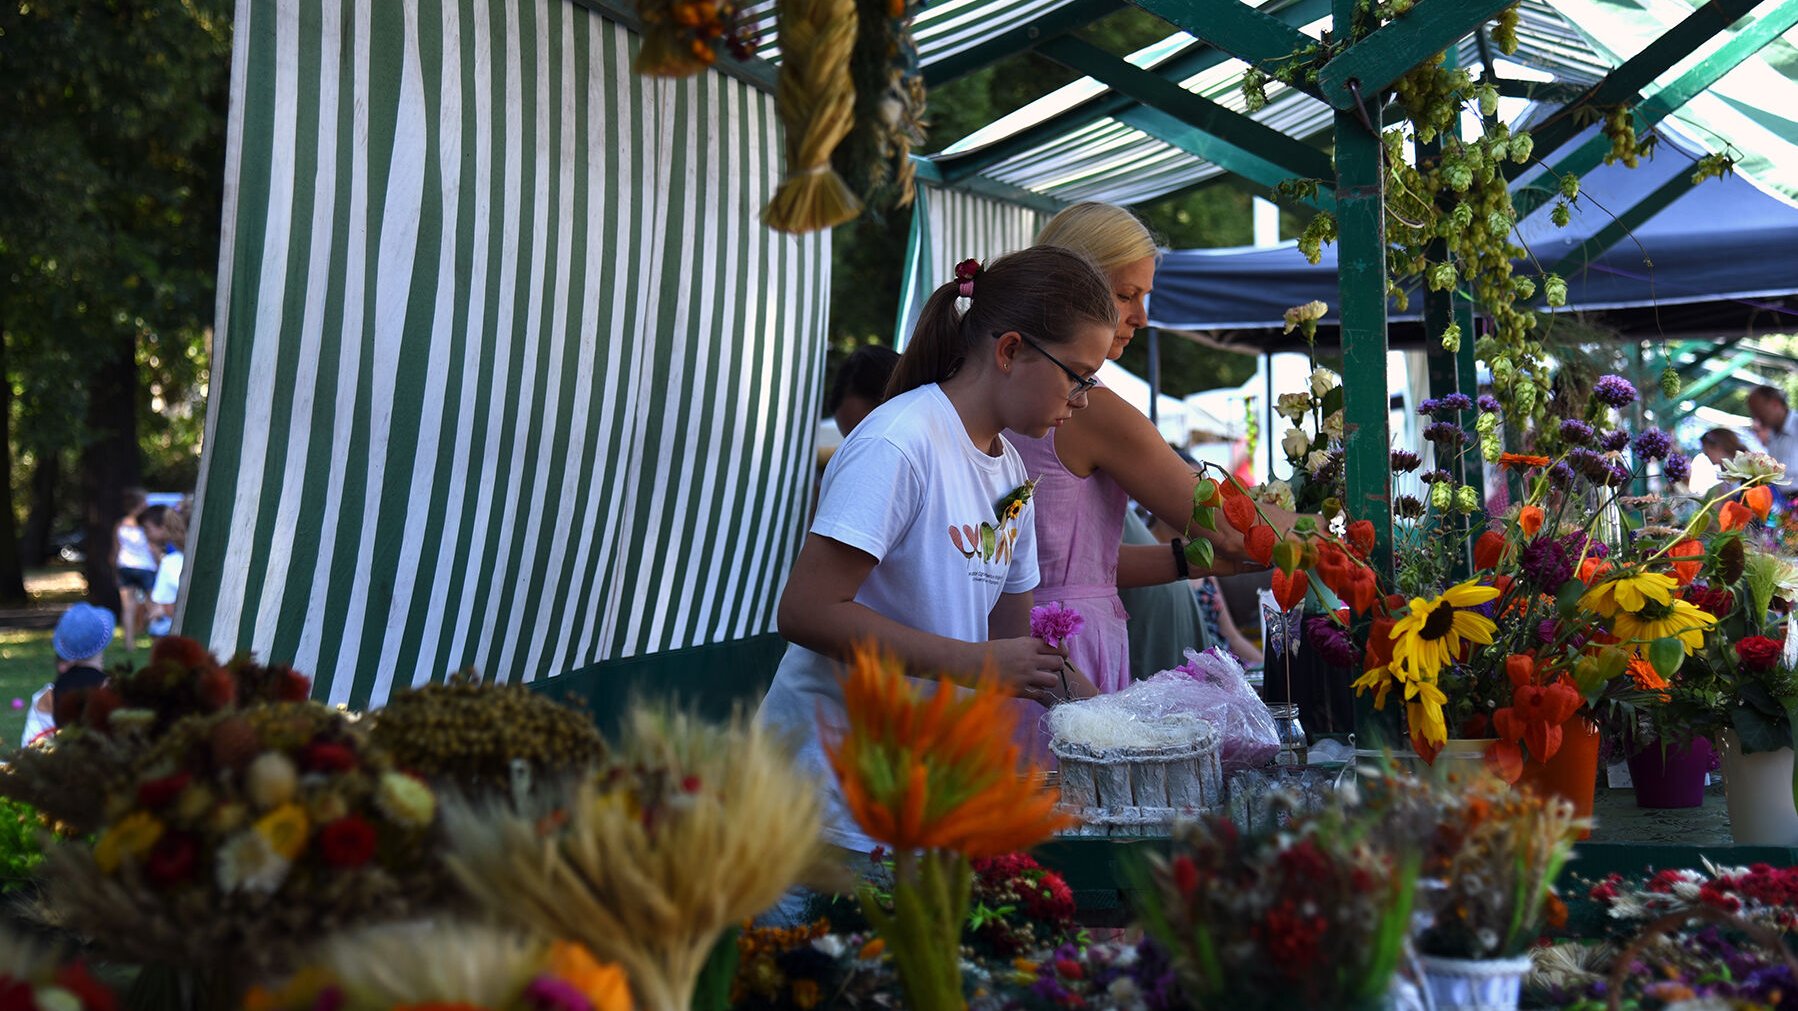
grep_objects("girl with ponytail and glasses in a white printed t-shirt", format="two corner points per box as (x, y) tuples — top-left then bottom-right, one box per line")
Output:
(759, 246), (1117, 853)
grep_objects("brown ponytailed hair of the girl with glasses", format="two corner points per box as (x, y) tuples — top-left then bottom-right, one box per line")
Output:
(886, 246), (1118, 399)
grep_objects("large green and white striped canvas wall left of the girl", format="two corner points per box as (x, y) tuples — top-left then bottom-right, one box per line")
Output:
(182, 0), (831, 705)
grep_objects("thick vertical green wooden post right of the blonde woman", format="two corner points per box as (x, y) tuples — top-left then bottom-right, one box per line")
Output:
(1334, 0), (1404, 748)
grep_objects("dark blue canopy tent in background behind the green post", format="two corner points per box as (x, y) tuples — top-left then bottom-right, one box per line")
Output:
(1149, 126), (1798, 331)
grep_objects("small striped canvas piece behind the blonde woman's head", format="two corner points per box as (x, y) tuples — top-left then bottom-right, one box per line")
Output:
(894, 182), (1050, 351)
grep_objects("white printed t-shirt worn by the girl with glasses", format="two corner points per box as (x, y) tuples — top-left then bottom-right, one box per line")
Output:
(757, 385), (1037, 853)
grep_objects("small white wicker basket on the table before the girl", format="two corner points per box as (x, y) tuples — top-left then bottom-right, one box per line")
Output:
(1050, 721), (1224, 837)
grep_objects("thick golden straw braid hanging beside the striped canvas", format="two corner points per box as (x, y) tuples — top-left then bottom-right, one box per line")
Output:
(762, 0), (861, 232)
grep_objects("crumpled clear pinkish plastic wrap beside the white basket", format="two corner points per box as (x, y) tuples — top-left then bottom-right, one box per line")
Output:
(1150, 646), (1280, 777)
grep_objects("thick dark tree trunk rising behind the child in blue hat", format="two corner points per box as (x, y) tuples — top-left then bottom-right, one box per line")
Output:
(81, 336), (144, 610)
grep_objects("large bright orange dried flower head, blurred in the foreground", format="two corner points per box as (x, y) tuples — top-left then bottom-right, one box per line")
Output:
(827, 646), (1073, 856)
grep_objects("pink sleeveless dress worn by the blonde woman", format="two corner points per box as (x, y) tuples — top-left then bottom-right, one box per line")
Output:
(1005, 428), (1131, 754)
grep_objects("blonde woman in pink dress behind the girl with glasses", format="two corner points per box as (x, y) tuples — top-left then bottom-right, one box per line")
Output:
(1005, 203), (1293, 691)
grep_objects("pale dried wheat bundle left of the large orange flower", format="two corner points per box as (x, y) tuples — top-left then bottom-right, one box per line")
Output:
(442, 709), (823, 1011)
